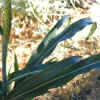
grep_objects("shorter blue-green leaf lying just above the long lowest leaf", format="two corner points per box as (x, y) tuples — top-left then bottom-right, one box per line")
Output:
(7, 56), (81, 99)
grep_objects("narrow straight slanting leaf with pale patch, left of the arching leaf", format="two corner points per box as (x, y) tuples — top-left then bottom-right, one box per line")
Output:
(27, 16), (69, 67)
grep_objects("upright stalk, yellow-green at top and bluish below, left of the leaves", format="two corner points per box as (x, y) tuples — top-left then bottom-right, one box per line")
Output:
(2, 0), (11, 100)
